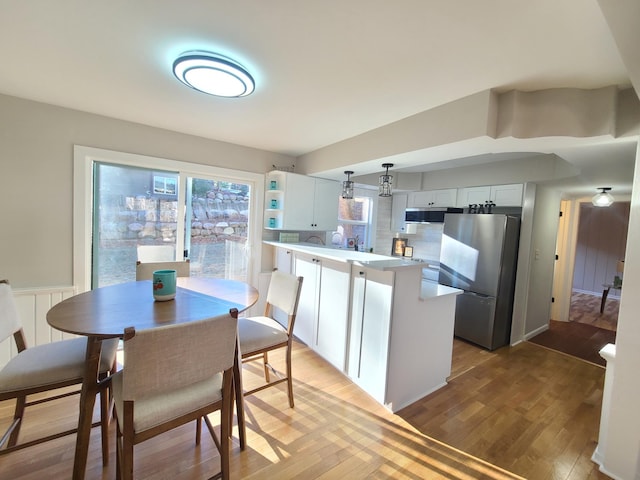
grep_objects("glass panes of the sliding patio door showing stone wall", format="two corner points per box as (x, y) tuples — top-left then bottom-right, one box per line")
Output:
(91, 162), (251, 288)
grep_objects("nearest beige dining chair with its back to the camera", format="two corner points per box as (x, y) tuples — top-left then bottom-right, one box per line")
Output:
(113, 308), (238, 480)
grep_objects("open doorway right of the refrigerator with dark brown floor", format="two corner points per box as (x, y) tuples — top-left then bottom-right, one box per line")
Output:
(530, 199), (630, 366)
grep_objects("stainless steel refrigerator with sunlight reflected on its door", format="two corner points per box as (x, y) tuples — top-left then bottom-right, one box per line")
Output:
(438, 214), (520, 350)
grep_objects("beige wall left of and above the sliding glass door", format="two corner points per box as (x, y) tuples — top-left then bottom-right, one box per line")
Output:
(0, 95), (294, 287)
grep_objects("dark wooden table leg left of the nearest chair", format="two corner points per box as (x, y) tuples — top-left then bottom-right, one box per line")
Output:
(73, 337), (102, 480)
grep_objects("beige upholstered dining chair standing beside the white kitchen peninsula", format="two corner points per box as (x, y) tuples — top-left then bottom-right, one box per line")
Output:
(238, 270), (302, 411)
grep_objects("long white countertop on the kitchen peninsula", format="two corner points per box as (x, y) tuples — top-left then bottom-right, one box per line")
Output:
(263, 241), (428, 270)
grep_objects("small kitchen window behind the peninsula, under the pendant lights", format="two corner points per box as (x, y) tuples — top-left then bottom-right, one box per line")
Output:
(331, 195), (373, 249)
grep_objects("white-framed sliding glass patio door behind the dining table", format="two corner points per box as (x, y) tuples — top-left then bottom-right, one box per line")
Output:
(74, 146), (264, 290)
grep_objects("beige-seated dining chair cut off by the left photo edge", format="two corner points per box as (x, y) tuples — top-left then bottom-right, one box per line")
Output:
(0, 280), (118, 465)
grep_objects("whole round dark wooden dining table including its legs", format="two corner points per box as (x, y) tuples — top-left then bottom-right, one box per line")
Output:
(47, 277), (258, 480)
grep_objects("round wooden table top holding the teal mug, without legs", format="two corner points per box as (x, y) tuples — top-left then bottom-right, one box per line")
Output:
(47, 277), (258, 338)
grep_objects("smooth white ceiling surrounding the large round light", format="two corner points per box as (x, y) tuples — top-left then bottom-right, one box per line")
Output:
(0, 0), (635, 196)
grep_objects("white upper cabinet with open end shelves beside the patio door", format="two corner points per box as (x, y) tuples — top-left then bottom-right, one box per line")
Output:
(264, 171), (340, 231)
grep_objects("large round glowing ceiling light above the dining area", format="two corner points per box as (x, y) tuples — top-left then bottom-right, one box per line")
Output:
(173, 50), (255, 97)
